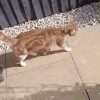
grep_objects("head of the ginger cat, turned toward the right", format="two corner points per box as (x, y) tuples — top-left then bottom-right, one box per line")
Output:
(64, 20), (78, 36)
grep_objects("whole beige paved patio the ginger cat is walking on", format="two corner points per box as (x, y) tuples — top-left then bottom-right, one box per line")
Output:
(0, 24), (100, 100)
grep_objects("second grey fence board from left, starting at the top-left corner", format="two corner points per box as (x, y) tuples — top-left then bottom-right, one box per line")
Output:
(1, 0), (17, 25)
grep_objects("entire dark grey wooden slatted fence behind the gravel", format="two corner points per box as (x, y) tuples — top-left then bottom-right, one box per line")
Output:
(0, 0), (100, 28)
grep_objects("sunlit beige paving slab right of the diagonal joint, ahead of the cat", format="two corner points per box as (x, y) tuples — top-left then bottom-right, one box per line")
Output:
(69, 24), (100, 85)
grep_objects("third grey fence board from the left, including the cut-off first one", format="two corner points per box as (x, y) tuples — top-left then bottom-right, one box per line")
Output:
(10, 0), (25, 23)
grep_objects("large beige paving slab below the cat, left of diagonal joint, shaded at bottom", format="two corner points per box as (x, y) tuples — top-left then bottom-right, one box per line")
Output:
(7, 50), (88, 100)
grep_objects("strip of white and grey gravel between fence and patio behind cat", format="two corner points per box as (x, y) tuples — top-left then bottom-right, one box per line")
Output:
(0, 2), (100, 52)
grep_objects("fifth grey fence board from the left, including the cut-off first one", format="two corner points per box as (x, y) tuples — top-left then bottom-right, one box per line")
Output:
(32, 0), (43, 18)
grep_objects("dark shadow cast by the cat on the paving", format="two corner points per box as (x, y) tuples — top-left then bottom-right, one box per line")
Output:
(0, 50), (64, 68)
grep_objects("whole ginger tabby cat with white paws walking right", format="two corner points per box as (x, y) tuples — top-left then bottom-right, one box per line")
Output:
(0, 21), (77, 66)
